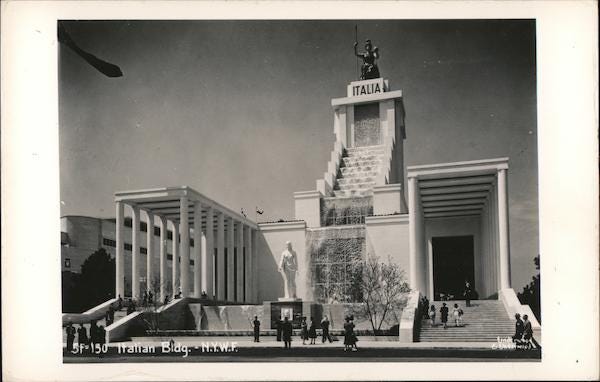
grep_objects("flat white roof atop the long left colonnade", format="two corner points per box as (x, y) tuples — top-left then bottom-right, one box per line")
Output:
(115, 186), (258, 230)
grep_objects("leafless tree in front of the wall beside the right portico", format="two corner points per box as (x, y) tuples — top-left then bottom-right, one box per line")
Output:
(356, 255), (410, 334)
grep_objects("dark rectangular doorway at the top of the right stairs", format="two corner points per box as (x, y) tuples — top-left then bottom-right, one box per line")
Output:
(431, 236), (475, 300)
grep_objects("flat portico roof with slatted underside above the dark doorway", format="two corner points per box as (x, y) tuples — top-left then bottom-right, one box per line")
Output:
(407, 158), (508, 218)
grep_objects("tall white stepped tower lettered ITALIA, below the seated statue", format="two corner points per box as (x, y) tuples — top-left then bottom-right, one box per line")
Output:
(294, 78), (407, 228)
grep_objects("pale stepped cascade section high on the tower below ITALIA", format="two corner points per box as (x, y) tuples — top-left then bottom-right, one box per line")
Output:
(333, 146), (383, 197)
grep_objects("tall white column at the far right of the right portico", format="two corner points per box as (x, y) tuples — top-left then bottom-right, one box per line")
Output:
(498, 169), (510, 289)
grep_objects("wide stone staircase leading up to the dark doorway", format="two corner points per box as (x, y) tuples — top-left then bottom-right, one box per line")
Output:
(419, 300), (515, 342)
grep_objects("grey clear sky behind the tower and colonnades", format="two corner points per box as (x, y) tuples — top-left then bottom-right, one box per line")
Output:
(59, 20), (539, 291)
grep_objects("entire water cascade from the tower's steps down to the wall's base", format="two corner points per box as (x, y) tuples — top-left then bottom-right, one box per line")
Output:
(306, 145), (384, 303)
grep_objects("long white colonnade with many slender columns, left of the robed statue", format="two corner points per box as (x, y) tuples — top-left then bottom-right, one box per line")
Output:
(115, 187), (258, 302)
